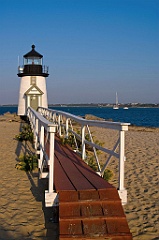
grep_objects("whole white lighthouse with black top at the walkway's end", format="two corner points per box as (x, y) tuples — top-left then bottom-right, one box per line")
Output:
(17, 45), (49, 116)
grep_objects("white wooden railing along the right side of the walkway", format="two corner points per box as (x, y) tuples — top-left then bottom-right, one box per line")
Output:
(38, 107), (130, 204)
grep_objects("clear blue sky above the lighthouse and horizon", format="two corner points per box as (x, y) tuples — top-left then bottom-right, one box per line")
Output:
(0, 0), (159, 105)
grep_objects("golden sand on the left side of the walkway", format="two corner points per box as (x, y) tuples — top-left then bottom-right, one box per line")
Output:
(0, 114), (58, 240)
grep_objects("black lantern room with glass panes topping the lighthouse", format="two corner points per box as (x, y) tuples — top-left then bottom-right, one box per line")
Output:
(17, 45), (49, 77)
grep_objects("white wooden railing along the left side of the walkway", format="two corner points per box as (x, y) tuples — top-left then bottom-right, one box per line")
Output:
(27, 107), (58, 207)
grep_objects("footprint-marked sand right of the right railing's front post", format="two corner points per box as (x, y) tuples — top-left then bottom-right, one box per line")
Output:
(124, 128), (159, 240)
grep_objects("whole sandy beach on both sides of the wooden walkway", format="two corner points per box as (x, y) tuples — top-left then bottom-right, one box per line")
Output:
(0, 115), (159, 240)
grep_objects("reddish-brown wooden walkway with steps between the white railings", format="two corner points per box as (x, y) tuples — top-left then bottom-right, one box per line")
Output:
(54, 137), (132, 240)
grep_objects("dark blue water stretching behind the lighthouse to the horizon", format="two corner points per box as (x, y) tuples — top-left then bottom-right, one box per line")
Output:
(0, 106), (159, 127)
